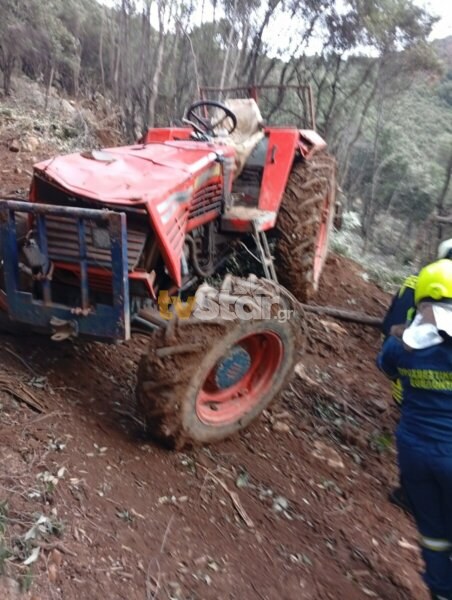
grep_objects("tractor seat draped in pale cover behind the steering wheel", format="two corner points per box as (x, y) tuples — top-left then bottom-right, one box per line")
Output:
(215, 98), (264, 178)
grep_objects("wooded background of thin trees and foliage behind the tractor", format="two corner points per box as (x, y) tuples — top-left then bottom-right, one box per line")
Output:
(0, 0), (452, 262)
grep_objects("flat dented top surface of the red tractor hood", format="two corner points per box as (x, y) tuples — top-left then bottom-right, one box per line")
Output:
(34, 141), (221, 205)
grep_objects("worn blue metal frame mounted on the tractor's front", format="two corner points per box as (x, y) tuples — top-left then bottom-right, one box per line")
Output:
(0, 199), (130, 341)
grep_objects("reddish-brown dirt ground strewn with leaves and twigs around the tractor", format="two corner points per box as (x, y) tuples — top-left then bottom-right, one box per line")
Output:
(0, 124), (427, 600)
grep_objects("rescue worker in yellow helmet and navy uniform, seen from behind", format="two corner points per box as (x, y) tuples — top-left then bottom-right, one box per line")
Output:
(377, 259), (452, 600)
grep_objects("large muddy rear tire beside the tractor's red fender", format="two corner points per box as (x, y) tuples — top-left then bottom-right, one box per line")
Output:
(275, 152), (336, 301)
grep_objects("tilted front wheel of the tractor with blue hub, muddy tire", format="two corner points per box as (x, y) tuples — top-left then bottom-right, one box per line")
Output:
(137, 276), (299, 449)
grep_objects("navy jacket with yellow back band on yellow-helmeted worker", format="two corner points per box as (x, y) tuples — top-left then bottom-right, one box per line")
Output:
(377, 336), (452, 444)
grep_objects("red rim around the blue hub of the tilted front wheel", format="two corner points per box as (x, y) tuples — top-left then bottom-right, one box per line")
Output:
(196, 331), (284, 427)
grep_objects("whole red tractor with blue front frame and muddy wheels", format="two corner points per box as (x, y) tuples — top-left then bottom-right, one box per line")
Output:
(0, 88), (335, 447)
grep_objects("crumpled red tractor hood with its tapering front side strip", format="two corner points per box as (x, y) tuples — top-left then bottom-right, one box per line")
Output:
(34, 141), (231, 285)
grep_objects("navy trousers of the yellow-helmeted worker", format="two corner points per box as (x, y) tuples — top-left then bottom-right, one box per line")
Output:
(397, 435), (452, 600)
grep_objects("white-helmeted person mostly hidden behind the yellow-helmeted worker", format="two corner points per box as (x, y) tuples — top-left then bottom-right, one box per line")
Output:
(381, 239), (452, 512)
